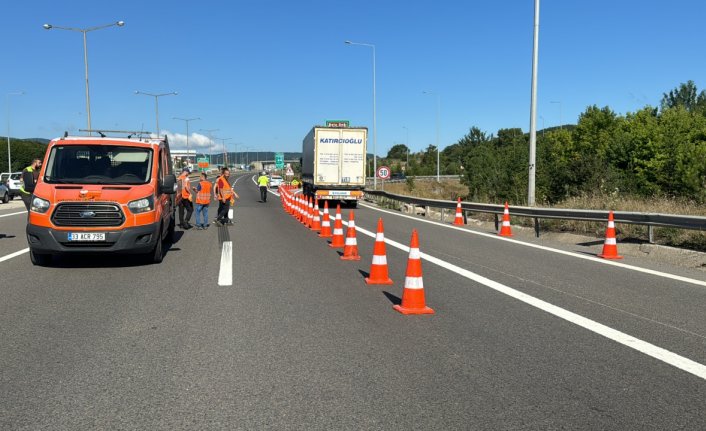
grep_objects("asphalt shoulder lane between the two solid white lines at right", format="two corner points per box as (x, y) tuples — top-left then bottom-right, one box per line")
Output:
(336, 200), (706, 363)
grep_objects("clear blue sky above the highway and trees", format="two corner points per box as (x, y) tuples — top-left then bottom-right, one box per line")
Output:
(0, 0), (706, 155)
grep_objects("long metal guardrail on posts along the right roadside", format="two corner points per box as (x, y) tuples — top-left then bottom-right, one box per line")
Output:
(365, 190), (706, 243)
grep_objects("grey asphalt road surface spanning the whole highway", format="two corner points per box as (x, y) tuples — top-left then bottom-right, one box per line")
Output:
(0, 176), (706, 430)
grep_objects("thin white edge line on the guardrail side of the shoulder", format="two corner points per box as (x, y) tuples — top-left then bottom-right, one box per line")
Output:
(361, 203), (706, 287)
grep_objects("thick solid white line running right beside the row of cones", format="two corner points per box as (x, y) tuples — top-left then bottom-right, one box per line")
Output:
(343, 222), (706, 380)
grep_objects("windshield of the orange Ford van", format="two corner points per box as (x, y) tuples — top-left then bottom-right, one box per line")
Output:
(44, 145), (152, 185)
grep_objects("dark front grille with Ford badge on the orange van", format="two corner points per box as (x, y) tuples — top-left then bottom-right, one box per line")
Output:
(51, 202), (125, 227)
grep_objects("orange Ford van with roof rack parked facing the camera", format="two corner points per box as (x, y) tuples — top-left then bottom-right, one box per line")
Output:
(27, 134), (177, 265)
